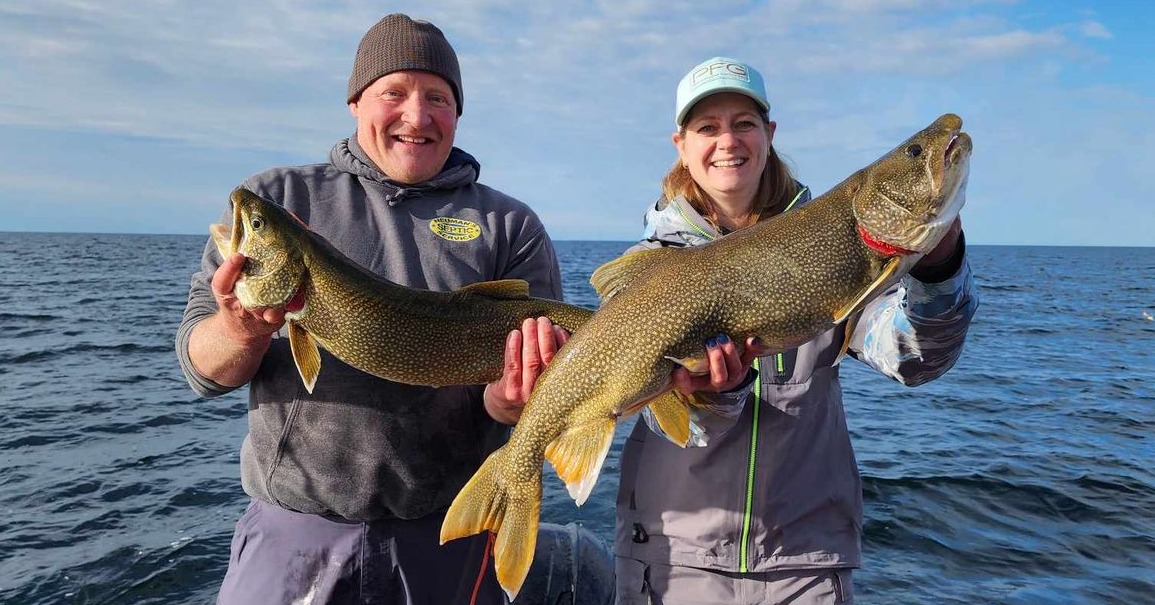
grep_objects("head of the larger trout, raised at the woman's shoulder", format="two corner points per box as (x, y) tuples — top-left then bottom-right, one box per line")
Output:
(854, 113), (971, 255)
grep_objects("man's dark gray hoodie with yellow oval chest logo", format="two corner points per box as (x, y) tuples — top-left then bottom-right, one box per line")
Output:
(177, 139), (561, 521)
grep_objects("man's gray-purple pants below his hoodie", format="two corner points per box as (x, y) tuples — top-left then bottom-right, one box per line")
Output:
(217, 499), (508, 605)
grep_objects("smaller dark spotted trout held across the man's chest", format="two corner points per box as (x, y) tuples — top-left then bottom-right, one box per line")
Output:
(210, 188), (593, 392)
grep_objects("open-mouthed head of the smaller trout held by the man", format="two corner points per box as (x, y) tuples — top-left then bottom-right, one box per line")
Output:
(209, 187), (308, 308)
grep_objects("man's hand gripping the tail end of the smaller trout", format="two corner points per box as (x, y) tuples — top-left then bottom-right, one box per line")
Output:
(484, 318), (569, 425)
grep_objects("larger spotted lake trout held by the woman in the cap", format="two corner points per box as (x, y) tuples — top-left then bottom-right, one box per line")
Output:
(441, 114), (971, 597)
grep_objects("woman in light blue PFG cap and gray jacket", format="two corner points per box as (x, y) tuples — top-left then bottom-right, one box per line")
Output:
(614, 58), (977, 605)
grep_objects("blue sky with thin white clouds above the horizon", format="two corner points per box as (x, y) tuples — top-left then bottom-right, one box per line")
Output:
(0, 0), (1155, 246)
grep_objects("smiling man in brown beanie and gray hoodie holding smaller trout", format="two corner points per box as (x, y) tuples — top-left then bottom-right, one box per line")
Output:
(177, 14), (567, 605)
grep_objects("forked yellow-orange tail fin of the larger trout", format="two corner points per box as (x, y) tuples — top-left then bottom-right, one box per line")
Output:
(441, 447), (542, 600)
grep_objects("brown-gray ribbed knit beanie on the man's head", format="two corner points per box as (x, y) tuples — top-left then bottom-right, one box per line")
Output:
(347, 13), (464, 115)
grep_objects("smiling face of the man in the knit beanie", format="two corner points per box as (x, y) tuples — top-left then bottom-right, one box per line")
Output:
(349, 70), (457, 185)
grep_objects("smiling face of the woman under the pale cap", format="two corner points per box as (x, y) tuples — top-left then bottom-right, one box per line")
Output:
(673, 92), (777, 207)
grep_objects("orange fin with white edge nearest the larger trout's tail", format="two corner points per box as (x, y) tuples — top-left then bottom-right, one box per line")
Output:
(545, 416), (617, 506)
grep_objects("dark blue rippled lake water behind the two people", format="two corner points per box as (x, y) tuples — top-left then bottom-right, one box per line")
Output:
(0, 233), (1155, 604)
